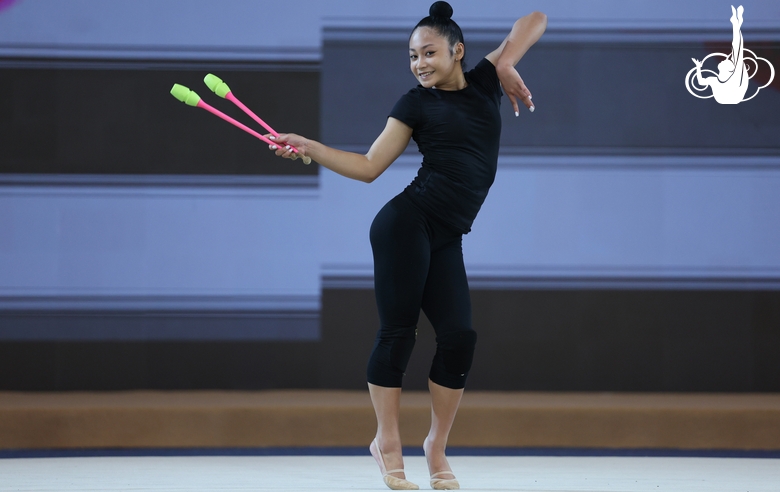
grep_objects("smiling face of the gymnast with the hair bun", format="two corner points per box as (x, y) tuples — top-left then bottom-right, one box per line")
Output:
(409, 27), (466, 90)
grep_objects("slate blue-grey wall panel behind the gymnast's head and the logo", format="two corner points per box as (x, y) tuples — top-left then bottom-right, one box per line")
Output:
(322, 36), (780, 155)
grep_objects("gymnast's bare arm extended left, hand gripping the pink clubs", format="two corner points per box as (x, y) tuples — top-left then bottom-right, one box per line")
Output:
(276, 118), (412, 183)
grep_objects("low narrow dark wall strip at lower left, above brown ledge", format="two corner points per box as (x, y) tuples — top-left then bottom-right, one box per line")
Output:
(0, 342), (319, 391)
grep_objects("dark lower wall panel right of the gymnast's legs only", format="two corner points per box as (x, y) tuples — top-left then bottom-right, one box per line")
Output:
(464, 291), (780, 391)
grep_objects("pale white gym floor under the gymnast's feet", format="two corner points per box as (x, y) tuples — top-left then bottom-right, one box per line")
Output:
(0, 455), (780, 492)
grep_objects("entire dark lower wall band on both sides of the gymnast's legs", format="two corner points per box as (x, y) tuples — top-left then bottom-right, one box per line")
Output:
(0, 289), (780, 392)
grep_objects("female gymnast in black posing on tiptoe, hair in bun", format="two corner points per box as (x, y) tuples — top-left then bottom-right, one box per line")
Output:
(271, 2), (547, 490)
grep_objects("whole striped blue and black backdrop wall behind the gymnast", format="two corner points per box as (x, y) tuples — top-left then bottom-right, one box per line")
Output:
(0, 0), (780, 391)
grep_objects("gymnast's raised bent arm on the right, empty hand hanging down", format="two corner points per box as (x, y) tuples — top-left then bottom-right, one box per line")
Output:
(485, 12), (547, 115)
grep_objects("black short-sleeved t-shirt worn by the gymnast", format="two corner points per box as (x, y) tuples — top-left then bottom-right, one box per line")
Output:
(390, 58), (502, 234)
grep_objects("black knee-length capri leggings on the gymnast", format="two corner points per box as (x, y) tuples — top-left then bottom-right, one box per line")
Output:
(368, 193), (477, 389)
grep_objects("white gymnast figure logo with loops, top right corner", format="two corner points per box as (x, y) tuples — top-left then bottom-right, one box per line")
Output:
(685, 5), (775, 104)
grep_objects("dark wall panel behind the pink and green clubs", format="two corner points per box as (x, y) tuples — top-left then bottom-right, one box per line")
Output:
(0, 65), (320, 175)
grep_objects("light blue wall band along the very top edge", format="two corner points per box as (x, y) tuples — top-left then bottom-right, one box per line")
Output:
(0, 0), (780, 62)
